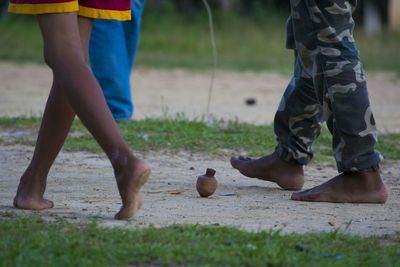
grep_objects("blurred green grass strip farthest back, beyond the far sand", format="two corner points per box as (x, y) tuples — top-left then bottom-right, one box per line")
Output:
(0, 9), (400, 73)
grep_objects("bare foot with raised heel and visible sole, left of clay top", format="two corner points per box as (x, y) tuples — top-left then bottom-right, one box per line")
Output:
(115, 158), (150, 220)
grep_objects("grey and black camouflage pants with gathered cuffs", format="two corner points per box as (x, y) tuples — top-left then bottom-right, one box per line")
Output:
(274, 0), (382, 172)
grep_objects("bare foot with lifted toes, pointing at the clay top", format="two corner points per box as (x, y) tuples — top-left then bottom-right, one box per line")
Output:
(231, 153), (304, 190)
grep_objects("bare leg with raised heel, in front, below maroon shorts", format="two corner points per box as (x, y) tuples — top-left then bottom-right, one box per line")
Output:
(15, 13), (150, 219)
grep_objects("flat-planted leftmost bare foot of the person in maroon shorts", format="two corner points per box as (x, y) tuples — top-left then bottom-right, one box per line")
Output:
(13, 173), (54, 210)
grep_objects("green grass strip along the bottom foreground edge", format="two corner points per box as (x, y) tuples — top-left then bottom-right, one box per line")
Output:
(0, 216), (400, 267)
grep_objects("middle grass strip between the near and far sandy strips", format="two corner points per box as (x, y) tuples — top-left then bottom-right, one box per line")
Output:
(0, 118), (400, 161)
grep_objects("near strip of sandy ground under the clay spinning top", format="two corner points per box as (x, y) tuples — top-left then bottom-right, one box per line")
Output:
(0, 146), (400, 235)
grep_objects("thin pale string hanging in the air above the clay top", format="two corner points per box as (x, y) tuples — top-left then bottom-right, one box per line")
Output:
(203, 0), (218, 121)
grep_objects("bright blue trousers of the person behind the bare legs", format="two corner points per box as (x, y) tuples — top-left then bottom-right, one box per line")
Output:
(89, 0), (145, 120)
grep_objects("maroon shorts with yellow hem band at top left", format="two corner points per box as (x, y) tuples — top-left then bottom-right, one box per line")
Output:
(8, 0), (131, 20)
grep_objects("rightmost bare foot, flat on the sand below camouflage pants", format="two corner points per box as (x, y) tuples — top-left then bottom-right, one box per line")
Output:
(292, 171), (388, 203)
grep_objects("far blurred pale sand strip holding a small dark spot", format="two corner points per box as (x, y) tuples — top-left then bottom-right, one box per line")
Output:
(0, 63), (400, 132)
